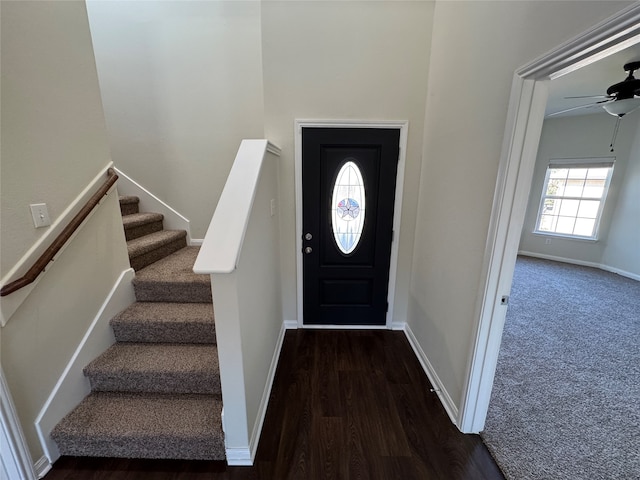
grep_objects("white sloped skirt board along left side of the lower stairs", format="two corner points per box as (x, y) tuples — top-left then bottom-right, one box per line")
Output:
(35, 268), (135, 463)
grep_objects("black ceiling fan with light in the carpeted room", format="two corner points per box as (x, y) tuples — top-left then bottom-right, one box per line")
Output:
(547, 61), (640, 118)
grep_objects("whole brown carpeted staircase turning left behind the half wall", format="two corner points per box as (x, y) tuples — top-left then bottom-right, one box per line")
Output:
(51, 196), (225, 460)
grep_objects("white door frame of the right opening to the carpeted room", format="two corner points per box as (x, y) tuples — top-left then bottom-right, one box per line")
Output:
(458, 3), (640, 433)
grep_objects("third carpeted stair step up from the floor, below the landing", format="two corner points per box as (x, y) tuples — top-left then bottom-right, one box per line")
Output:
(111, 302), (216, 343)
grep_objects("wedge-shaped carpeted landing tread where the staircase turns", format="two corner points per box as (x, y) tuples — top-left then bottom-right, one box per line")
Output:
(134, 247), (211, 284)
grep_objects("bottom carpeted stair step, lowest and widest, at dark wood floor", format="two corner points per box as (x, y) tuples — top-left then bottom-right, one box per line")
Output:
(51, 393), (225, 460)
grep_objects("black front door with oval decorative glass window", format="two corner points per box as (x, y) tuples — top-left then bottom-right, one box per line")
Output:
(302, 127), (400, 325)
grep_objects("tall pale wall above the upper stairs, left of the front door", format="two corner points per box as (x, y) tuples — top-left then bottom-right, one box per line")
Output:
(87, 0), (263, 238)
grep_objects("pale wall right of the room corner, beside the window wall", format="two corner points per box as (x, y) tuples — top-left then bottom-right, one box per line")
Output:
(602, 120), (640, 277)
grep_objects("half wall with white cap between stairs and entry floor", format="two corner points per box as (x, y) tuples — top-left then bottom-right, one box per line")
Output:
(193, 140), (284, 465)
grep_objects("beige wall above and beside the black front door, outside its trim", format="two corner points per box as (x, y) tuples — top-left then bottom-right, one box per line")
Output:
(262, 1), (434, 321)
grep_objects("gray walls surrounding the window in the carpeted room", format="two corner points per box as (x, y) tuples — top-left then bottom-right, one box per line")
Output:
(520, 112), (640, 273)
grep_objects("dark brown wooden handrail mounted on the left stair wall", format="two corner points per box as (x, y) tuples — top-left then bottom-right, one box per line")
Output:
(0, 168), (118, 297)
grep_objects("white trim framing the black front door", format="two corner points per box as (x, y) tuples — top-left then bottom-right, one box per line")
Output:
(294, 119), (409, 329)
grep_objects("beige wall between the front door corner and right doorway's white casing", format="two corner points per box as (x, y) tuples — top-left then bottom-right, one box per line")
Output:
(409, 1), (628, 412)
